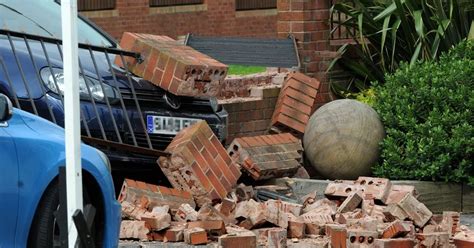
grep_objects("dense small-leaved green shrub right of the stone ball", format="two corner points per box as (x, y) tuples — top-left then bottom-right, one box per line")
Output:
(373, 41), (474, 185)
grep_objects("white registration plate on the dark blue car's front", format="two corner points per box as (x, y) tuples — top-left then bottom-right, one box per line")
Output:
(146, 115), (200, 134)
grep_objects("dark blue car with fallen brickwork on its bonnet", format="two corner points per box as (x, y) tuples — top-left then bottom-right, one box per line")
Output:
(0, 0), (227, 168)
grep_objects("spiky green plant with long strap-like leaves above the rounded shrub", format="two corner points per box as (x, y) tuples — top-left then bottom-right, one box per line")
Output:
(329, 0), (474, 94)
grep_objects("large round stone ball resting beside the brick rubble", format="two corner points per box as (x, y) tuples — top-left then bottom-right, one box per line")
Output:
(303, 99), (385, 179)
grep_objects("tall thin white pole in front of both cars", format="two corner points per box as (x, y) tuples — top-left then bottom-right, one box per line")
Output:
(61, 0), (82, 248)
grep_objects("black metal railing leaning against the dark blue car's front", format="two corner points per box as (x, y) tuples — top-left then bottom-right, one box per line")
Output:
(0, 29), (171, 156)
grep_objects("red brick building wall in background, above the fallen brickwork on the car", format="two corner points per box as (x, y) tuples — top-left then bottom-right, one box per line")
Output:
(81, 0), (277, 38)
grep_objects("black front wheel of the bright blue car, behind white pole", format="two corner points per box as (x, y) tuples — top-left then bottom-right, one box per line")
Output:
(28, 182), (96, 248)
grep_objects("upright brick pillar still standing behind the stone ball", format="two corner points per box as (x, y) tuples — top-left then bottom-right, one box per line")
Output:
(277, 0), (335, 109)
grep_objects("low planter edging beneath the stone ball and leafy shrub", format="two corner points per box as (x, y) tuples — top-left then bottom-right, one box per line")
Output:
(269, 178), (474, 213)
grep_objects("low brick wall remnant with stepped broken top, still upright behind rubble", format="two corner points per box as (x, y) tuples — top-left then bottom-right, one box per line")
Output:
(219, 85), (281, 143)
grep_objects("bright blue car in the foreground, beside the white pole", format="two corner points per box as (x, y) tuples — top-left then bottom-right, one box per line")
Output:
(0, 94), (120, 248)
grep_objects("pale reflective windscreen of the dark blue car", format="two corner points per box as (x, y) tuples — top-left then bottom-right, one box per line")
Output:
(0, 0), (113, 47)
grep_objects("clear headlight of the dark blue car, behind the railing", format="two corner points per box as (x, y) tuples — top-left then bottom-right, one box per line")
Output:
(40, 67), (118, 102)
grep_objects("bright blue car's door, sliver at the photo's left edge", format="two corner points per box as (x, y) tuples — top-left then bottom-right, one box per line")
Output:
(0, 122), (18, 244)
